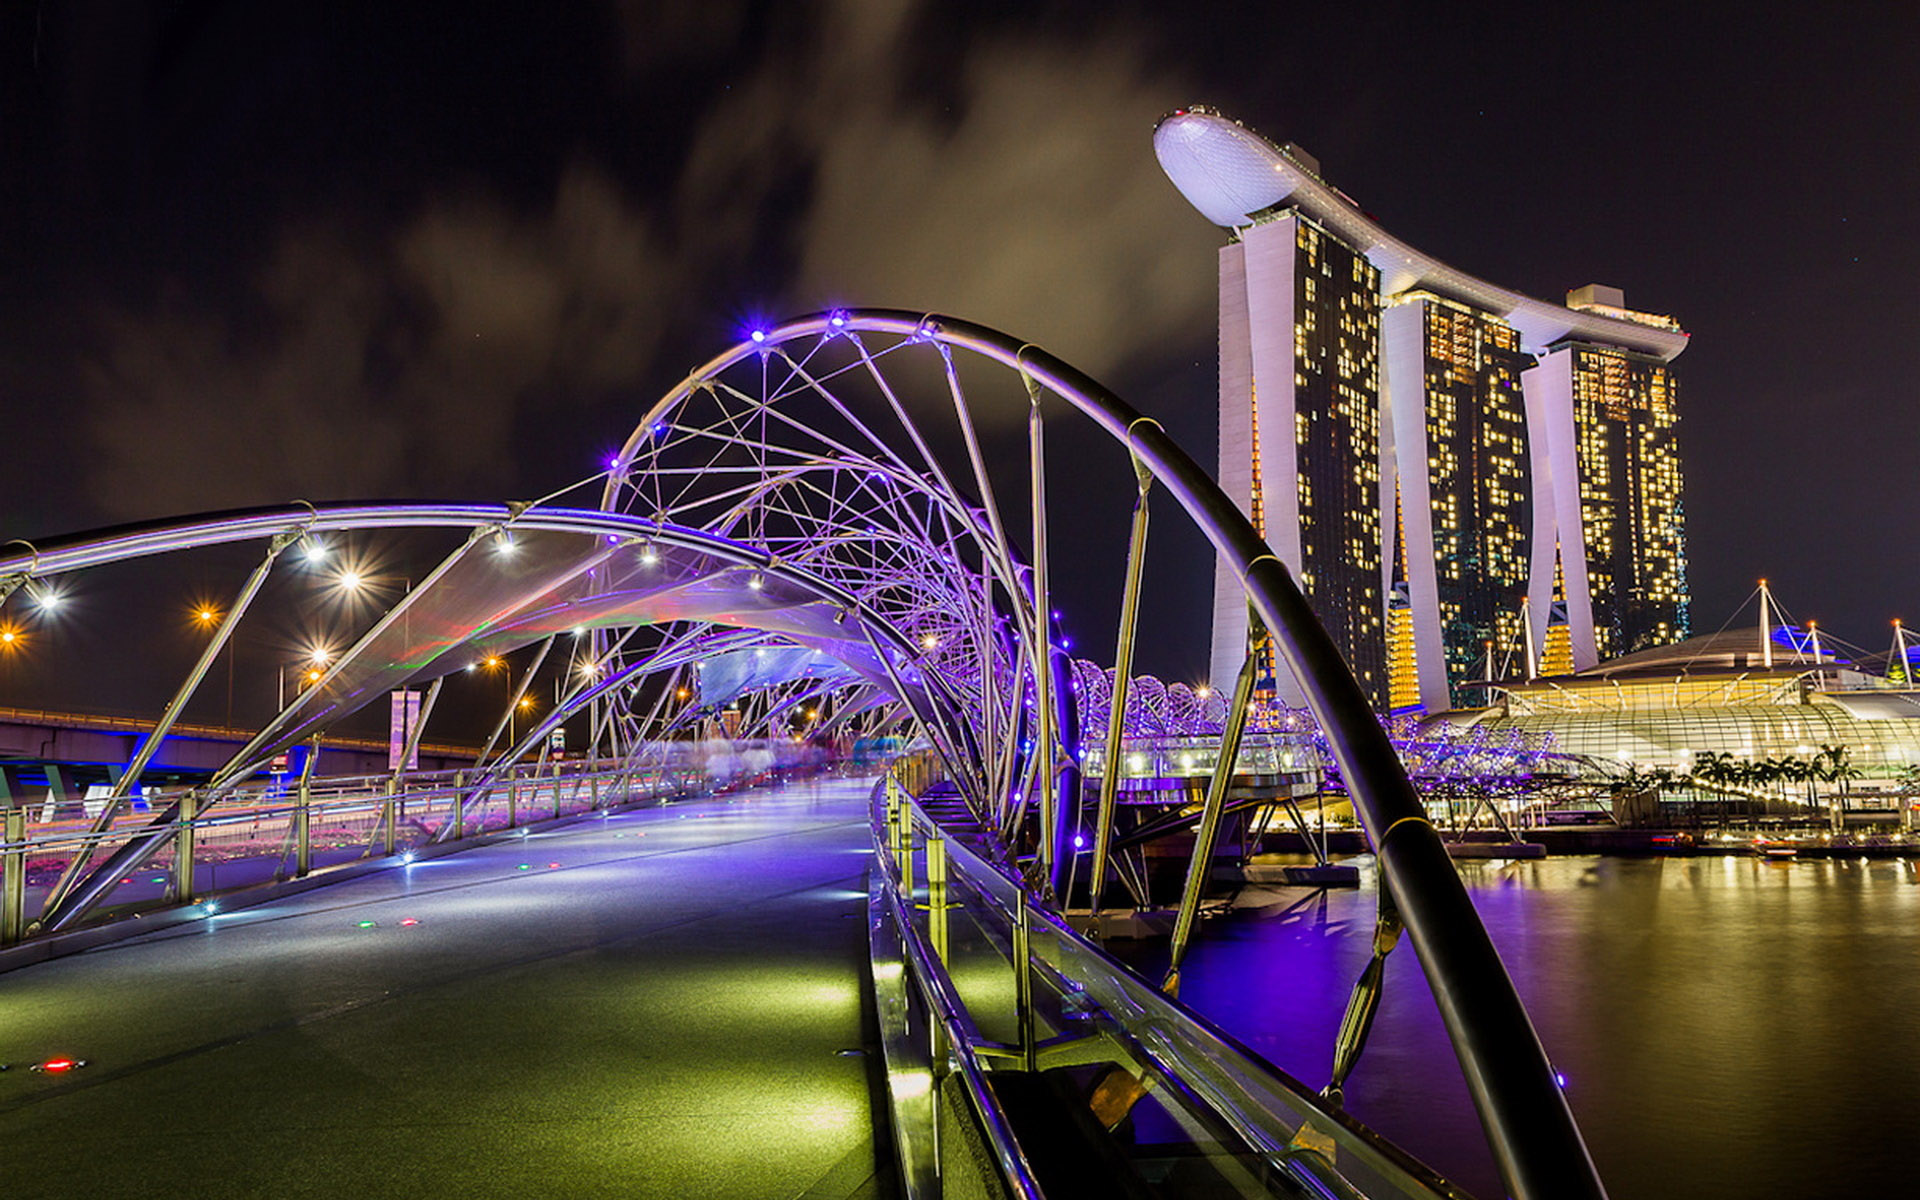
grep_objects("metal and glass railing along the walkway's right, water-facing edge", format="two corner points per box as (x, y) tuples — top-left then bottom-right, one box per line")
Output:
(870, 776), (1463, 1198)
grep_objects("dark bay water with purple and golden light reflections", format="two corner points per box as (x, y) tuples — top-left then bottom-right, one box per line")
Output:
(1152, 858), (1920, 1200)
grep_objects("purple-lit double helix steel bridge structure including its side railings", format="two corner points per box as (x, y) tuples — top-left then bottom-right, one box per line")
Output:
(0, 309), (1603, 1198)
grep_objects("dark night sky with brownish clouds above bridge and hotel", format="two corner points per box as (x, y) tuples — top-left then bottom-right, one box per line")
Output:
(0, 0), (1920, 691)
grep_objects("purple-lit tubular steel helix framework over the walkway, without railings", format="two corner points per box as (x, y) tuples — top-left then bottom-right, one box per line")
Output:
(0, 309), (1599, 1196)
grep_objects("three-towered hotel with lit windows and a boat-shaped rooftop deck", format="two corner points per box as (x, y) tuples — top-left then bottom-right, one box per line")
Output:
(1154, 109), (1688, 712)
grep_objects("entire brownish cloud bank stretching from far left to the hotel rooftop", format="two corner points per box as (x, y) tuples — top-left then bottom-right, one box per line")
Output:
(84, 2), (1215, 516)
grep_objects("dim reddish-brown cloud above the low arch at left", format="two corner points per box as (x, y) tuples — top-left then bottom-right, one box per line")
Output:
(86, 169), (672, 516)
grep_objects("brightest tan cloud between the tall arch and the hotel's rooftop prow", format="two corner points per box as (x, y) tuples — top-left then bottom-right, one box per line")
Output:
(682, 2), (1217, 384)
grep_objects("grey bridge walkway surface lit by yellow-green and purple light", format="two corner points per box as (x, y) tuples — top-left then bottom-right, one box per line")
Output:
(0, 780), (891, 1200)
